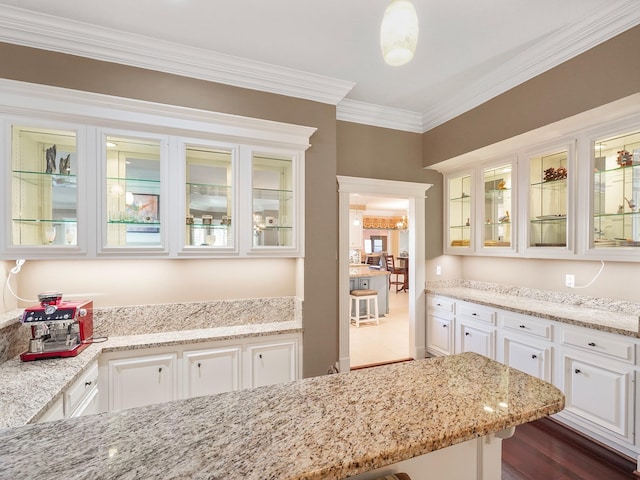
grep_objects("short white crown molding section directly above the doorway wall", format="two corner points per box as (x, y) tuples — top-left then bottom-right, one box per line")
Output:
(336, 99), (424, 133)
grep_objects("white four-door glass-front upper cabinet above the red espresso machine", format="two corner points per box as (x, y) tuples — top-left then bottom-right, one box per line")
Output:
(0, 87), (315, 259)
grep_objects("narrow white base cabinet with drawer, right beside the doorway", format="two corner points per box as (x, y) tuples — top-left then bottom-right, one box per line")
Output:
(427, 295), (455, 355)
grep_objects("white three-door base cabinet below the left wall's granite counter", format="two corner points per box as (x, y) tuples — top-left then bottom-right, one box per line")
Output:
(100, 334), (302, 411)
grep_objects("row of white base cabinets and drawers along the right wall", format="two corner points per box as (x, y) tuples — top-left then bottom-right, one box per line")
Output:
(427, 294), (640, 458)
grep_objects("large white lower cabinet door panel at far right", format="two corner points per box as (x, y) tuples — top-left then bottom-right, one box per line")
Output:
(564, 356), (633, 437)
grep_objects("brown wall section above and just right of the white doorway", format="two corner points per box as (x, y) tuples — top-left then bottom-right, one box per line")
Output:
(338, 121), (443, 259)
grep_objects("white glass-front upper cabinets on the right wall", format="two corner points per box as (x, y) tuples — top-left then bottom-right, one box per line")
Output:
(440, 110), (640, 262)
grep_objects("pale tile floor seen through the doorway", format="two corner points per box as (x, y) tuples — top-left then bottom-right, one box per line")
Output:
(349, 289), (409, 367)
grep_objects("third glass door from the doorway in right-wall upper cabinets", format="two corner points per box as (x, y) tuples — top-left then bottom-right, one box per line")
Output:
(529, 149), (569, 247)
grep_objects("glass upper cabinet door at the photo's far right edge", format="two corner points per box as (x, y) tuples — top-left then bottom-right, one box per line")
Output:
(592, 132), (640, 248)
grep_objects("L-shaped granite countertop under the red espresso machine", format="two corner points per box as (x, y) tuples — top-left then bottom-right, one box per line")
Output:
(0, 321), (302, 428)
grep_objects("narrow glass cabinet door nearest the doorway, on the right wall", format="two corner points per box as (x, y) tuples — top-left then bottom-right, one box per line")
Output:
(447, 175), (473, 253)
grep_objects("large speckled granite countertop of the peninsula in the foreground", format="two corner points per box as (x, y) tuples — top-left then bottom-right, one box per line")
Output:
(0, 353), (564, 480)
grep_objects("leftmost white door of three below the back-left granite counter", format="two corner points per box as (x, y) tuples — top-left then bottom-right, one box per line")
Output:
(108, 353), (178, 411)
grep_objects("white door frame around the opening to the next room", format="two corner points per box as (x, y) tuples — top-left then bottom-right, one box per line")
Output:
(336, 175), (433, 372)
